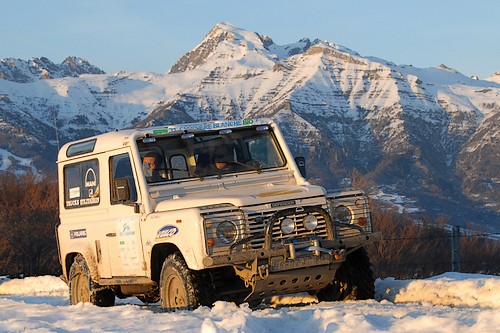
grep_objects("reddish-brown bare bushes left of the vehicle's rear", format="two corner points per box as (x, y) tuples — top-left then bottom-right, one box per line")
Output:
(0, 174), (59, 276)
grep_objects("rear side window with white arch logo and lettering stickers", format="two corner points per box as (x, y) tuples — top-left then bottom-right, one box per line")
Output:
(64, 159), (100, 209)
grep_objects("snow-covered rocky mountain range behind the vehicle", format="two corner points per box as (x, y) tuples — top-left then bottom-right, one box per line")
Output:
(0, 23), (500, 230)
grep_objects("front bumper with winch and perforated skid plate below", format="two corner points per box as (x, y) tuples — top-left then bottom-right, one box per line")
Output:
(203, 232), (382, 301)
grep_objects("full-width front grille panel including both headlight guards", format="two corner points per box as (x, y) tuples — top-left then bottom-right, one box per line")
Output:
(201, 191), (372, 255)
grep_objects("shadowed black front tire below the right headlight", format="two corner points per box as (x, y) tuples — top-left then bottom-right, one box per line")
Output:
(317, 248), (375, 301)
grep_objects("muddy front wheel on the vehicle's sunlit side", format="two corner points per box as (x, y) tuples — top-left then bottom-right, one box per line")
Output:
(160, 253), (210, 309)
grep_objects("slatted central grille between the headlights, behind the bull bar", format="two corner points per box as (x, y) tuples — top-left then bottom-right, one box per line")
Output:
(244, 207), (329, 249)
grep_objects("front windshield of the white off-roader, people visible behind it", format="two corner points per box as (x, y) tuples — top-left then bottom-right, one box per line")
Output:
(137, 126), (286, 183)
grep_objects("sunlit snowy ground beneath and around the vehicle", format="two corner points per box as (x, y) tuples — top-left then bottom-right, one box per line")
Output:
(0, 273), (500, 333)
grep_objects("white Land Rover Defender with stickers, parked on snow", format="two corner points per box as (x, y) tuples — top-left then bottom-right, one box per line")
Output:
(57, 119), (381, 308)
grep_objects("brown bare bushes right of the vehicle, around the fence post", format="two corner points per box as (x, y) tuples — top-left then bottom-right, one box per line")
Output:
(369, 208), (500, 279)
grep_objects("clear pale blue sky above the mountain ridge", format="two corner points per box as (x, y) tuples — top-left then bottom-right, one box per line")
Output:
(0, 0), (500, 78)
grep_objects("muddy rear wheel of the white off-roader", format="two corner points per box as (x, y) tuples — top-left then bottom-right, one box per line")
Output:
(69, 254), (115, 306)
